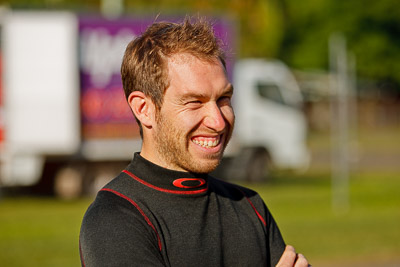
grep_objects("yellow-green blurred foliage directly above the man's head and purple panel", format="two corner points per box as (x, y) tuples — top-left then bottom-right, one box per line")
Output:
(126, 0), (283, 57)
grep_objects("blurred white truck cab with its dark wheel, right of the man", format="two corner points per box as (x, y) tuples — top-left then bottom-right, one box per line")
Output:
(212, 59), (310, 181)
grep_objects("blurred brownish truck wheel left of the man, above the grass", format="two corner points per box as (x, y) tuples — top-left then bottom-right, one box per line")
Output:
(54, 167), (83, 200)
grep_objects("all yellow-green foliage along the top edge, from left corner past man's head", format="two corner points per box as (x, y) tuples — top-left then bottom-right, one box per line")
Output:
(0, 0), (283, 57)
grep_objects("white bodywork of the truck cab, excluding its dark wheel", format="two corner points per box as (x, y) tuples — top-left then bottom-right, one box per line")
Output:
(228, 59), (309, 168)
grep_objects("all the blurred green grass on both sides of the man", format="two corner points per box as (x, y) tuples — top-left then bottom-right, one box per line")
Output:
(0, 172), (400, 267)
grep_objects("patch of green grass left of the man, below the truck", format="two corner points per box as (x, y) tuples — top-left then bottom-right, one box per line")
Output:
(0, 198), (90, 267)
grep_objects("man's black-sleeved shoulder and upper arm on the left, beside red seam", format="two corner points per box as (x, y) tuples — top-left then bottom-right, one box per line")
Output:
(79, 182), (162, 266)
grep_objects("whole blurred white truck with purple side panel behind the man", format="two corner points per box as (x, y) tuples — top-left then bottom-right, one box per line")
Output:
(0, 12), (309, 197)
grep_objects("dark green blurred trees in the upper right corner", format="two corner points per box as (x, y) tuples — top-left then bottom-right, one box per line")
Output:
(279, 0), (400, 90)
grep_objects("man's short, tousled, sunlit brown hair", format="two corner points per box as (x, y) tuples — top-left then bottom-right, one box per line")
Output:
(121, 18), (225, 137)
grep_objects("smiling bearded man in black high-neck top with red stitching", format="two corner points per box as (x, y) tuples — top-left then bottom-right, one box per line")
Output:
(80, 19), (308, 267)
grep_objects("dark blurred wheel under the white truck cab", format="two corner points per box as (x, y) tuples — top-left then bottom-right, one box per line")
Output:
(246, 149), (270, 182)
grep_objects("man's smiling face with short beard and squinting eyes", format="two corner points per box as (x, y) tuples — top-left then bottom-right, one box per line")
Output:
(154, 54), (235, 173)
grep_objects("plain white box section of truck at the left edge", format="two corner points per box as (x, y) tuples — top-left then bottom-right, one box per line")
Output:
(0, 12), (80, 191)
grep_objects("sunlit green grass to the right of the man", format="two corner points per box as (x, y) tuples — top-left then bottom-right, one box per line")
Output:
(242, 169), (400, 266)
